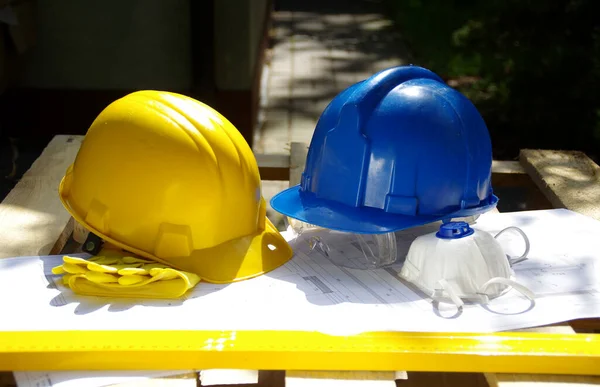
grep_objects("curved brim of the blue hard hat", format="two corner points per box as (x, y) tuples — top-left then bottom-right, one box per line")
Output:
(271, 185), (498, 234)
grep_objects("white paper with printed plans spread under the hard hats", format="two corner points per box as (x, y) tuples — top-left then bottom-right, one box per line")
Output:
(0, 210), (600, 334)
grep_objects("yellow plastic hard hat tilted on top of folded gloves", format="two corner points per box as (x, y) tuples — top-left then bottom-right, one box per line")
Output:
(59, 91), (293, 283)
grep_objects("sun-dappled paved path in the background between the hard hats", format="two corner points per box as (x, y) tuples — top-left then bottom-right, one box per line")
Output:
(254, 0), (410, 227)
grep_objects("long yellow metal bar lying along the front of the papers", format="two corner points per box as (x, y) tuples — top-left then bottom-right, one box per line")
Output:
(0, 331), (600, 375)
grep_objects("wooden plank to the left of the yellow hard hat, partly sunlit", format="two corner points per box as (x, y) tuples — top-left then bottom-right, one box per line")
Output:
(0, 136), (83, 258)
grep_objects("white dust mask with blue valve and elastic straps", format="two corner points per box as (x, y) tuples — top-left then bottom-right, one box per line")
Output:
(400, 222), (534, 307)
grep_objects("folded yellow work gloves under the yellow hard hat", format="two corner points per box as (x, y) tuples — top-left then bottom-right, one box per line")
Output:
(52, 256), (200, 299)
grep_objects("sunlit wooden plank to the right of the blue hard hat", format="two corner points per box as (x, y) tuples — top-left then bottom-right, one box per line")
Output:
(520, 149), (600, 220)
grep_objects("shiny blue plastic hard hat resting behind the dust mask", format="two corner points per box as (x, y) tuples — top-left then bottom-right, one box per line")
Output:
(271, 66), (498, 234)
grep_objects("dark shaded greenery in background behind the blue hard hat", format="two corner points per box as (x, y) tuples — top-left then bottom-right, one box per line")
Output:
(386, 0), (600, 161)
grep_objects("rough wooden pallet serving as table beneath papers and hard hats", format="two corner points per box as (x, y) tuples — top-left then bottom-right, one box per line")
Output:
(0, 135), (600, 387)
